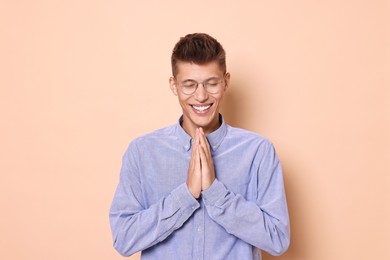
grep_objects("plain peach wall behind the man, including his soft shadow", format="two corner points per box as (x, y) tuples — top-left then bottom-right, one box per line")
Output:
(0, 0), (390, 260)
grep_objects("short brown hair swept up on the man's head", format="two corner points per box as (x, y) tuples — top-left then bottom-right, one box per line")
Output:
(171, 33), (226, 76)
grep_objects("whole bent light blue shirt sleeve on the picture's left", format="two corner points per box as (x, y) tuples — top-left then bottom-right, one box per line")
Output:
(110, 144), (200, 256)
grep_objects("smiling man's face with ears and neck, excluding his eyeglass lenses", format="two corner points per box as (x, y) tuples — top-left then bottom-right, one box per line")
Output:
(169, 61), (230, 136)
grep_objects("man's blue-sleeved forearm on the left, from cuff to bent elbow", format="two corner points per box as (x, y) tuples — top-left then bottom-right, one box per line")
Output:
(110, 184), (199, 256)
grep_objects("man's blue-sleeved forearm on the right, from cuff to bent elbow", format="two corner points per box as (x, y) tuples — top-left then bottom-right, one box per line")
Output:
(202, 180), (290, 255)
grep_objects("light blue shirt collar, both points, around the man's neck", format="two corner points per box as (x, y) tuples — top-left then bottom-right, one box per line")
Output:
(176, 114), (227, 151)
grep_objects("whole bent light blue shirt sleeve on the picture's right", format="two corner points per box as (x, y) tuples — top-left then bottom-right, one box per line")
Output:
(202, 145), (290, 255)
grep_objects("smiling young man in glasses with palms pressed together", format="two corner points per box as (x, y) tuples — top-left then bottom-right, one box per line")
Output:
(110, 34), (290, 260)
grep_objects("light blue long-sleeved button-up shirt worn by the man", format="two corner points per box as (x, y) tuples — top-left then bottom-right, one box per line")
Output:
(110, 117), (290, 260)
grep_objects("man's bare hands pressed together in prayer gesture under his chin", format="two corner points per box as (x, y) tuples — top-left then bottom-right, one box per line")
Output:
(186, 128), (215, 198)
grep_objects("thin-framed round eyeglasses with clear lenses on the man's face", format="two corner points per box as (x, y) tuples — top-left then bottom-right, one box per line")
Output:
(176, 78), (225, 95)
